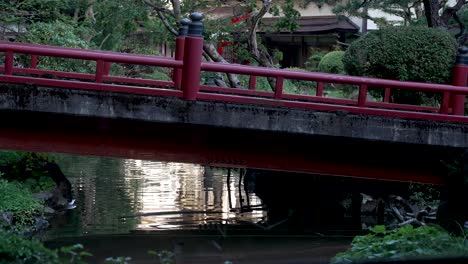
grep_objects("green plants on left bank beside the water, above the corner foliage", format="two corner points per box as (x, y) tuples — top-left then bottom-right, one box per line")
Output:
(0, 179), (44, 229)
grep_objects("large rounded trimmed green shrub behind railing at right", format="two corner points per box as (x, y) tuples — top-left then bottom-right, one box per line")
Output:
(343, 27), (457, 83)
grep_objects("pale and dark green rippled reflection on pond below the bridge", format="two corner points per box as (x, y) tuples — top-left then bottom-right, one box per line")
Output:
(47, 155), (265, 238)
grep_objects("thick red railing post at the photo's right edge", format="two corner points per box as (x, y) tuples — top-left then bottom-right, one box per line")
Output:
(450, 48), (468, 115)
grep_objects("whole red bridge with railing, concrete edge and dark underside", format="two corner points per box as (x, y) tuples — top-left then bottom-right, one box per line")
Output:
(0, 14), (468, 186)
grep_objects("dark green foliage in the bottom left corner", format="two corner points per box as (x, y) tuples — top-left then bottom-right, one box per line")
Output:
(0, 229), (59, 264)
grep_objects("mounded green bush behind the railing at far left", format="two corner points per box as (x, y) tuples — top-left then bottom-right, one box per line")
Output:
(18, 21), (95, 73)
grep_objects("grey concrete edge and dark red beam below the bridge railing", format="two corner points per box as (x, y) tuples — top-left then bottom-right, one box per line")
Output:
(0, 84), (468, 183)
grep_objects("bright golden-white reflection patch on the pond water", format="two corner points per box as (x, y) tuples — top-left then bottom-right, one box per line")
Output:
(123, 160), (264, 230)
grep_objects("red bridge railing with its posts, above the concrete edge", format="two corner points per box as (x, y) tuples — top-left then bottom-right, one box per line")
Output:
(0, 12), (468, 123)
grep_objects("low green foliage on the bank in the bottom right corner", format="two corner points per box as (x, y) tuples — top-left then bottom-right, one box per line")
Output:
(331, 225), (468, 263)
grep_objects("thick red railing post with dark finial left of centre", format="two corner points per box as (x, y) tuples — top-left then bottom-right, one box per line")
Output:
(181, 13), (203, 100)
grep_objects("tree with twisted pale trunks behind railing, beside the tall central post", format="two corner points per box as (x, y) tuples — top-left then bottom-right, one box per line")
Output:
(143, 0), (300, 89)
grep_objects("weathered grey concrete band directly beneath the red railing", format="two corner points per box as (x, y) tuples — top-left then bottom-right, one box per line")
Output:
(0, 84), (468, 148)
